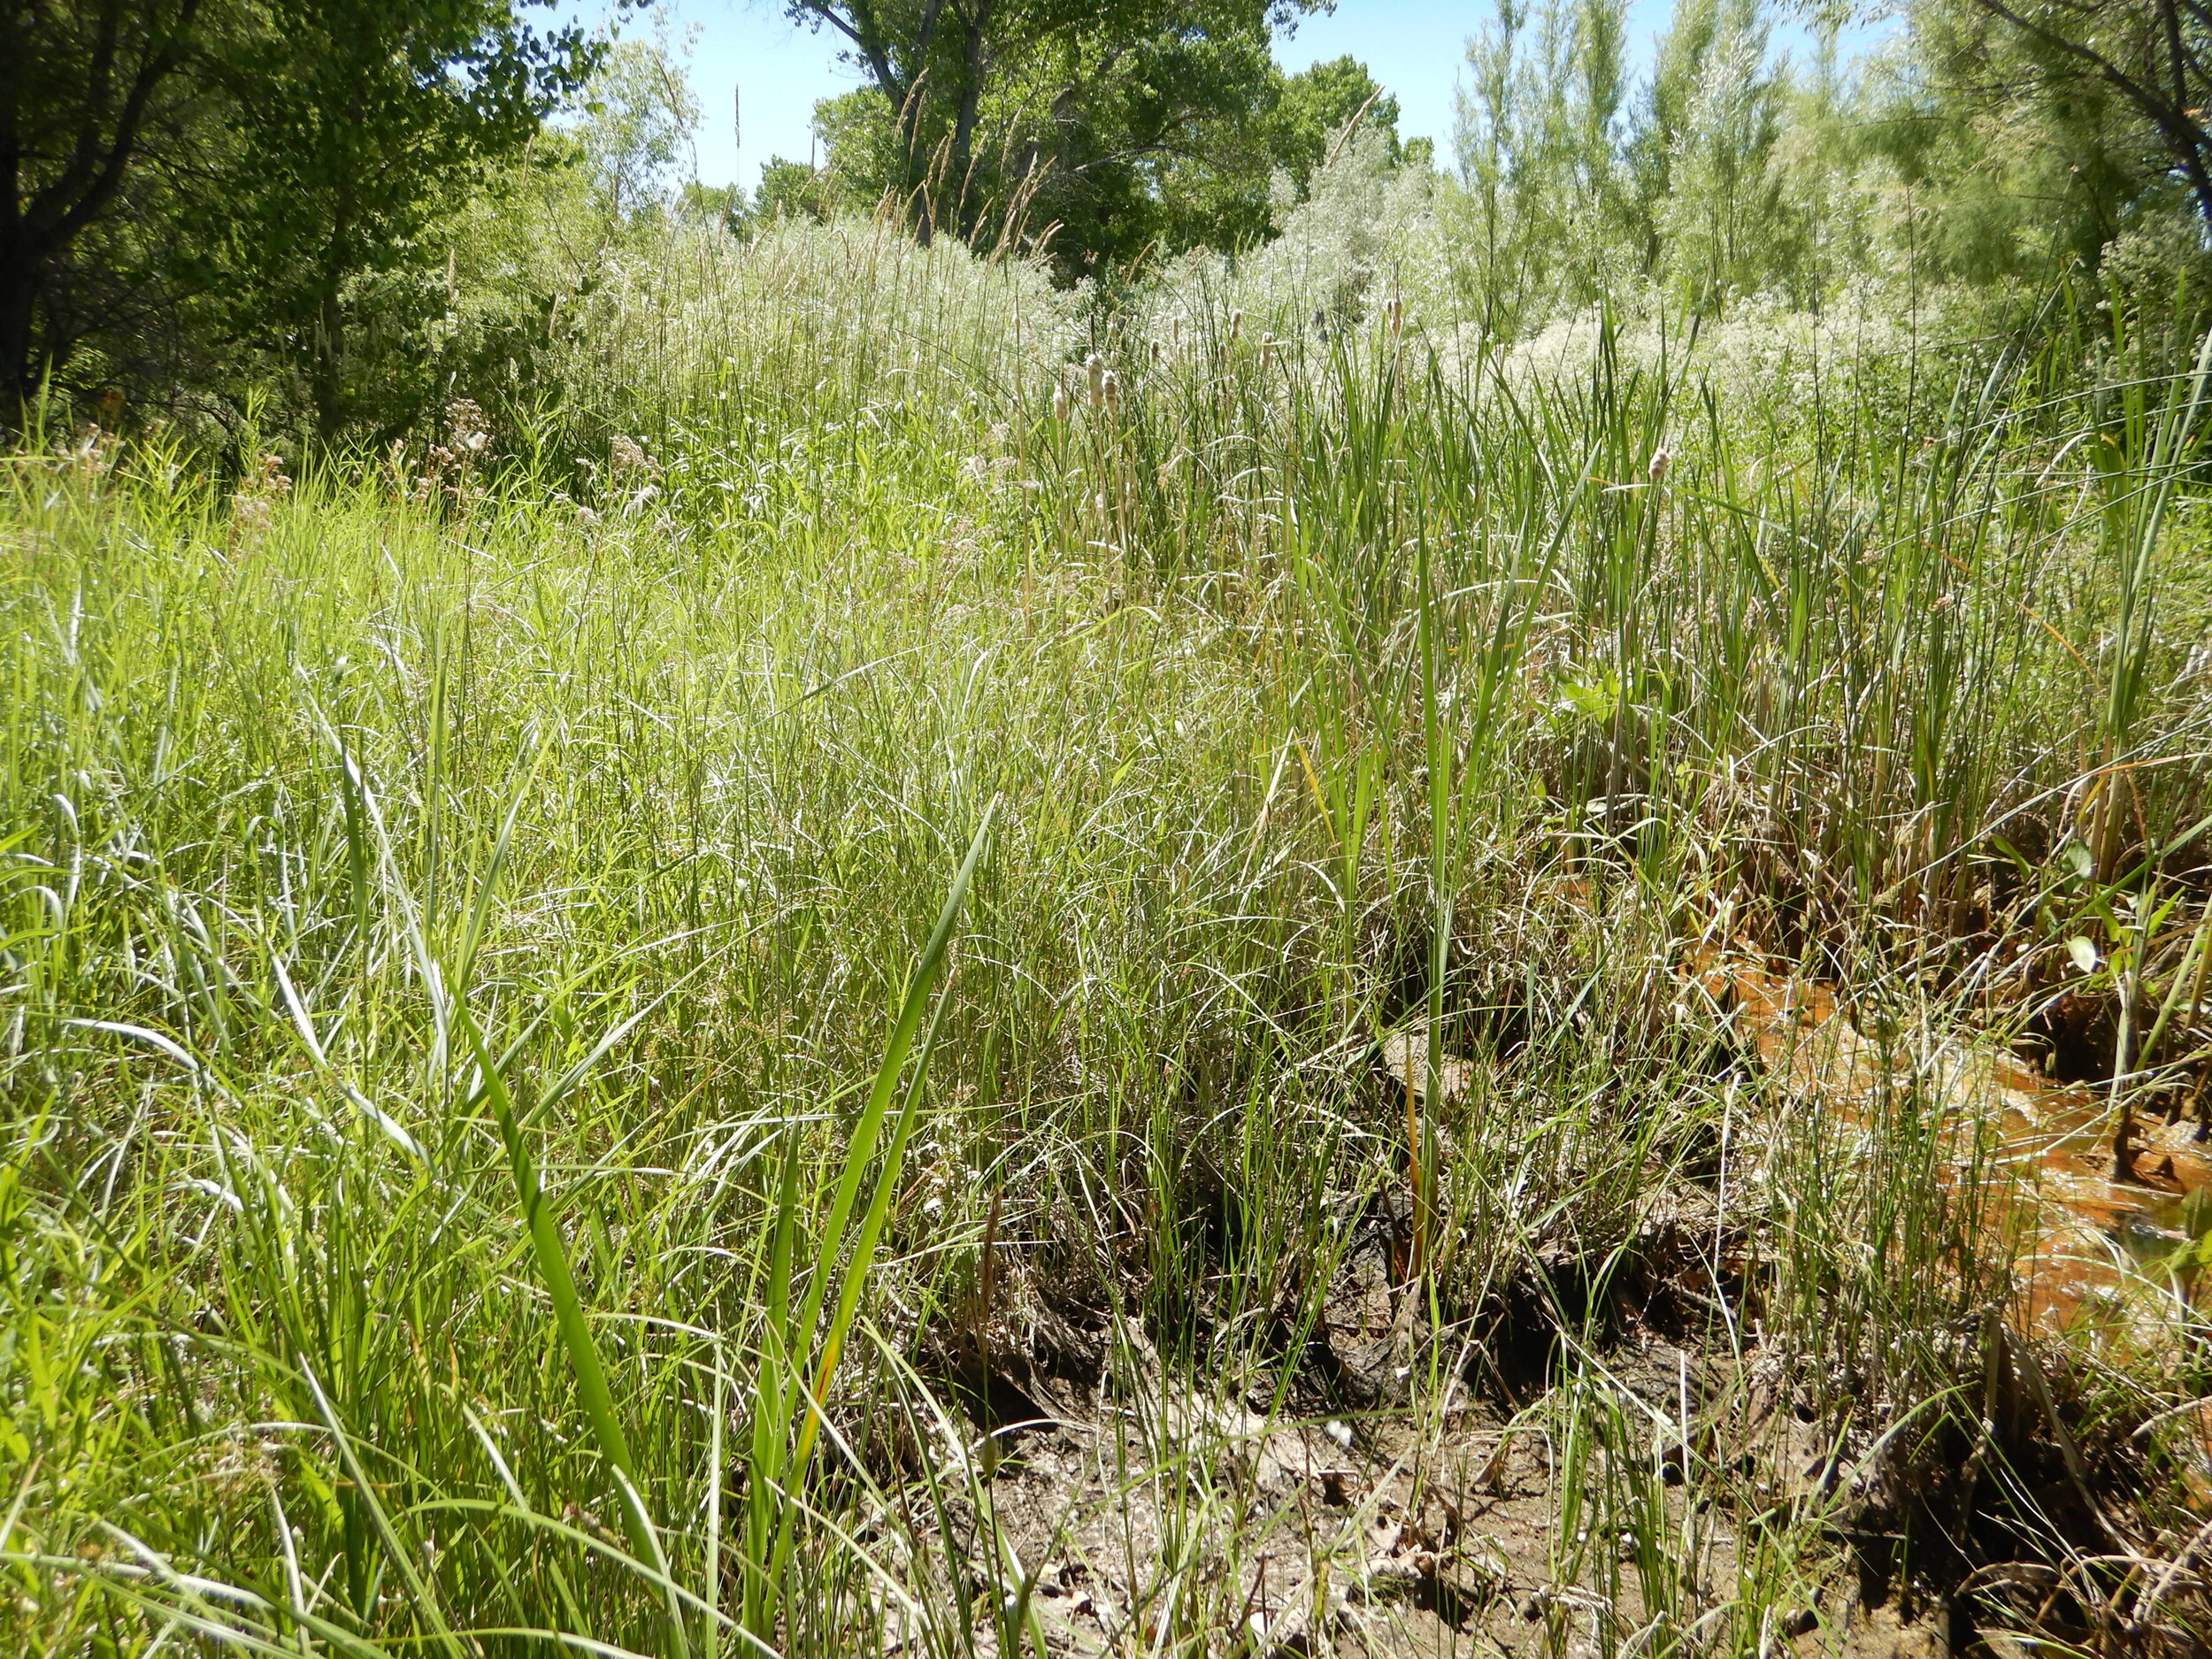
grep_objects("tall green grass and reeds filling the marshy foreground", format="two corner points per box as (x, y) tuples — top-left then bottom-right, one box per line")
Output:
(0, 230), (2212, 1653)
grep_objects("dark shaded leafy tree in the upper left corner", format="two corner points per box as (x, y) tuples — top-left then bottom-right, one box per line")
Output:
(0, 0), (600, 436)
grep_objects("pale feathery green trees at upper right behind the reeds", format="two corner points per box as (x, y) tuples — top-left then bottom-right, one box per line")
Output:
(1451, 0), (2208, 351)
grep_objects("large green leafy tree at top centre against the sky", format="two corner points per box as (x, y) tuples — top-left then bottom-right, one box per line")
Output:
(792, 0), (1398, 281)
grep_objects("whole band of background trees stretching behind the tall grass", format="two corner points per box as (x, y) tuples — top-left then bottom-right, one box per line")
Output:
(21, 0), (2212, 462)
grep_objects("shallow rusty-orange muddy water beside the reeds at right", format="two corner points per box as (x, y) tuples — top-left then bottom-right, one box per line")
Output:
(1693, 958), (2212, 1349)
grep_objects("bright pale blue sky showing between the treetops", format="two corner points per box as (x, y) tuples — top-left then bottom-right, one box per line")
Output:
(606, 0), (1885, 190)
